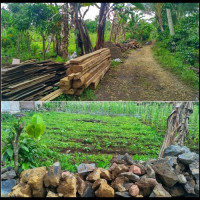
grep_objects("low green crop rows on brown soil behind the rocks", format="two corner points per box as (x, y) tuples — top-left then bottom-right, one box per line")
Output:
(2, 112), (164, 171)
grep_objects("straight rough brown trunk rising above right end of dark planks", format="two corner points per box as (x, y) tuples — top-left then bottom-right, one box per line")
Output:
(61, 3), (69, 59)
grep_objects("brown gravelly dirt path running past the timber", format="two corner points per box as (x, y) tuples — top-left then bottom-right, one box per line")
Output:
(95, 45), (199, 101)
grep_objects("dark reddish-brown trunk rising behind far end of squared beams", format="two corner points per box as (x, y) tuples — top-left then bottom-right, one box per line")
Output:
(96, 3), (110, 50)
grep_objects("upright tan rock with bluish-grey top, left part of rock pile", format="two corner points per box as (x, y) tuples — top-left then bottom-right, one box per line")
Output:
(44, 162), (61, 187)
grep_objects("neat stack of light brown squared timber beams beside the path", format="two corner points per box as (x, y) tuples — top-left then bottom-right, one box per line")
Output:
(60, 48), (111, 95)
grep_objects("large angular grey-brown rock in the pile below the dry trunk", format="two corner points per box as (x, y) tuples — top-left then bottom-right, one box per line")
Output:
(152, 160), (178, 187)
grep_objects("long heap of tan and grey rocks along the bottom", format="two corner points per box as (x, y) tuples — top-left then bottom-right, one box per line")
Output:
(2, 145), (199, 197)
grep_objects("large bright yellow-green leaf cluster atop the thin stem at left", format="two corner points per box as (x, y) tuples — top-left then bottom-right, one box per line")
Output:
(26, 114), (45, 140)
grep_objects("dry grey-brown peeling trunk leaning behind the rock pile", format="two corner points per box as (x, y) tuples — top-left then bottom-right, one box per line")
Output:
(159, 102), (193, 157)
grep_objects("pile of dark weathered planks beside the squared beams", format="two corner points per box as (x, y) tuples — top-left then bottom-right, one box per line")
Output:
(2, 60), (69, 101)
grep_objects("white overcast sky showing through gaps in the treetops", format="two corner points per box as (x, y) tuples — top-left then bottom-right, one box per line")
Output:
(1, 3), (154, 20)
